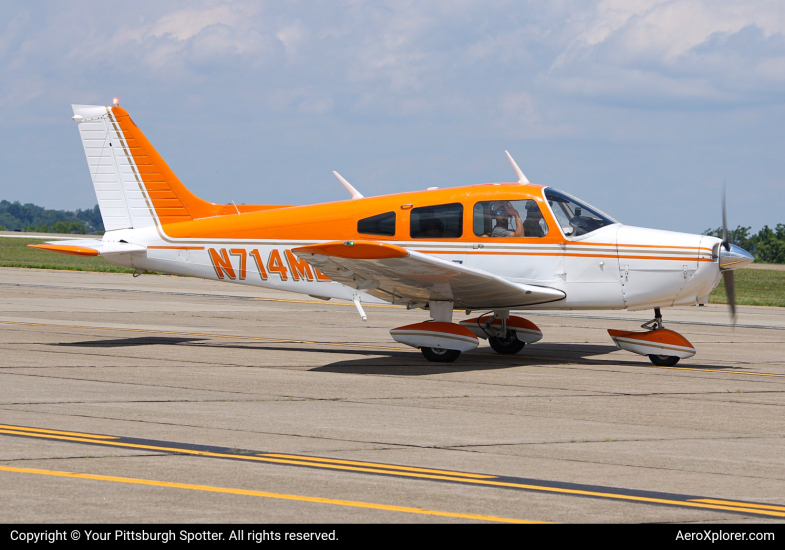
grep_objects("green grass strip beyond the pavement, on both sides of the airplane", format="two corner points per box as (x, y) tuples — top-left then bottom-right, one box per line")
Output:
(0, 237), (785, 307)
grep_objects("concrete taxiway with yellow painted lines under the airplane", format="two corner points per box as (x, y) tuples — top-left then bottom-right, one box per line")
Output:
(0, 268), (785, 524)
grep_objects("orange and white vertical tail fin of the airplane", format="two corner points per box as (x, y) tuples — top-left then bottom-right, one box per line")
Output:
(71, 105), (227, 231)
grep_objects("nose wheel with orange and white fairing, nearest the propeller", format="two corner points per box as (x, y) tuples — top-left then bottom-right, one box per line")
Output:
(608, 308), (695, 367)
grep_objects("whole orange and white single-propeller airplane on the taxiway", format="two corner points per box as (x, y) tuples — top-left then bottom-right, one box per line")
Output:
(31, 101), (753, 366)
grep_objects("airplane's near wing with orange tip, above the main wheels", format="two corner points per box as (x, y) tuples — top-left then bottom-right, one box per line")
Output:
(292, 241), (566, 309)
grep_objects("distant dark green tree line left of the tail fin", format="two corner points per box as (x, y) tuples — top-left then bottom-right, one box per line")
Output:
(0, 200), (104, 235)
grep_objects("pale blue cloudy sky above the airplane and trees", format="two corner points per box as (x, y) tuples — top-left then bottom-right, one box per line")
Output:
(0, 0), (785, 232)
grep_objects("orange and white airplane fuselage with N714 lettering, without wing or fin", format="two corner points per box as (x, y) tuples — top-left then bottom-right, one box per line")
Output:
(98, 183), (720, 310)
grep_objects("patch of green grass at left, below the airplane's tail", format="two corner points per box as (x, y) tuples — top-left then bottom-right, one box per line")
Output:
(0, 237), (134, 273)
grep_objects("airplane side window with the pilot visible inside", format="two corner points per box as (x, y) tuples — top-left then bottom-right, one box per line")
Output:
(474, 200), (548, 239)
